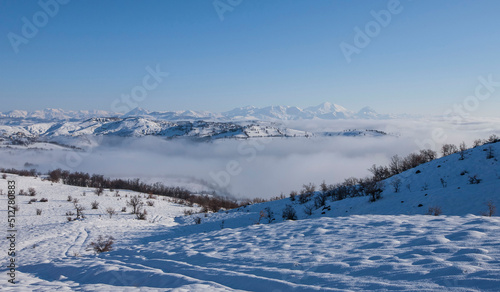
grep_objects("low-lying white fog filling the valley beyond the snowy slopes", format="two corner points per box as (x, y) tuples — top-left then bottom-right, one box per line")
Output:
(0, 119), (500, 198)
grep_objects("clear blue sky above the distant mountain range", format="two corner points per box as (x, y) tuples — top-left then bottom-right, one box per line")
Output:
(0, 0), (500, 116)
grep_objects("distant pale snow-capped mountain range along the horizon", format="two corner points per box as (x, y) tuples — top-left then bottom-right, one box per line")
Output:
(0, 102), (391, 124)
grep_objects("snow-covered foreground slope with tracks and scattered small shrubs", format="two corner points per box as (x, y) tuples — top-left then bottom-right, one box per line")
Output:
(0, 143), (500, 291)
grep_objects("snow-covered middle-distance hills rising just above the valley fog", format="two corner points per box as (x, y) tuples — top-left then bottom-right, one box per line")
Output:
(0, 117), (386, 145)
